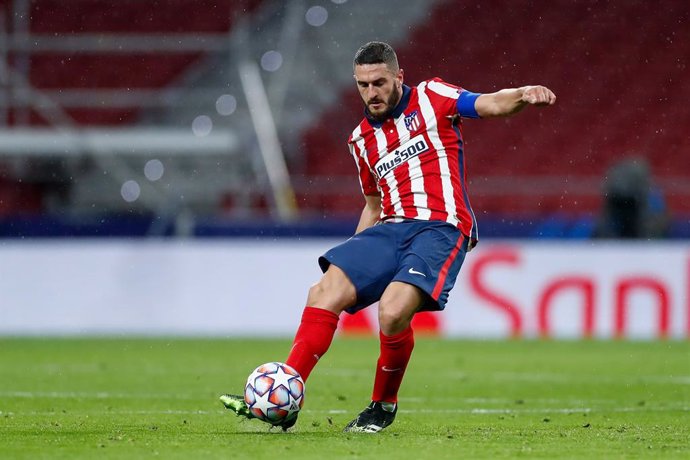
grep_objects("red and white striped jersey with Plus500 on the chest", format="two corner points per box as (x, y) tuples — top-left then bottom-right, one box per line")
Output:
(348, 78), (478, 242)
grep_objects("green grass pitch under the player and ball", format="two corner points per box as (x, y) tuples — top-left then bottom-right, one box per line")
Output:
(0, 337), (690, 459)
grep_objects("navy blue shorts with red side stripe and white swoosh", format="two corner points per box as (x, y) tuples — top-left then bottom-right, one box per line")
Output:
(319, 220), (468, 313)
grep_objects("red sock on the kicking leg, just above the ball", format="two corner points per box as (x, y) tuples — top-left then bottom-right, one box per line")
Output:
(285, 307), (339, 381)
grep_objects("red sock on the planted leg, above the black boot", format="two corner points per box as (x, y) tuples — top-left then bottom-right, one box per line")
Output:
(371, 327), (414, 403)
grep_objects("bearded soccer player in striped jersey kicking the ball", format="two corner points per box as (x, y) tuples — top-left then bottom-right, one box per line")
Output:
(221, 42), (556, 433)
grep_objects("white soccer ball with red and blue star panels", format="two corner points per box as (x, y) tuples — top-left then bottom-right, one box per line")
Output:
(244, 362), (304, 426)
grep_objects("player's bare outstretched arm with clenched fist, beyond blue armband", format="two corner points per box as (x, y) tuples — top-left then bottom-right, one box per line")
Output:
(474, 85), (556, 118)
